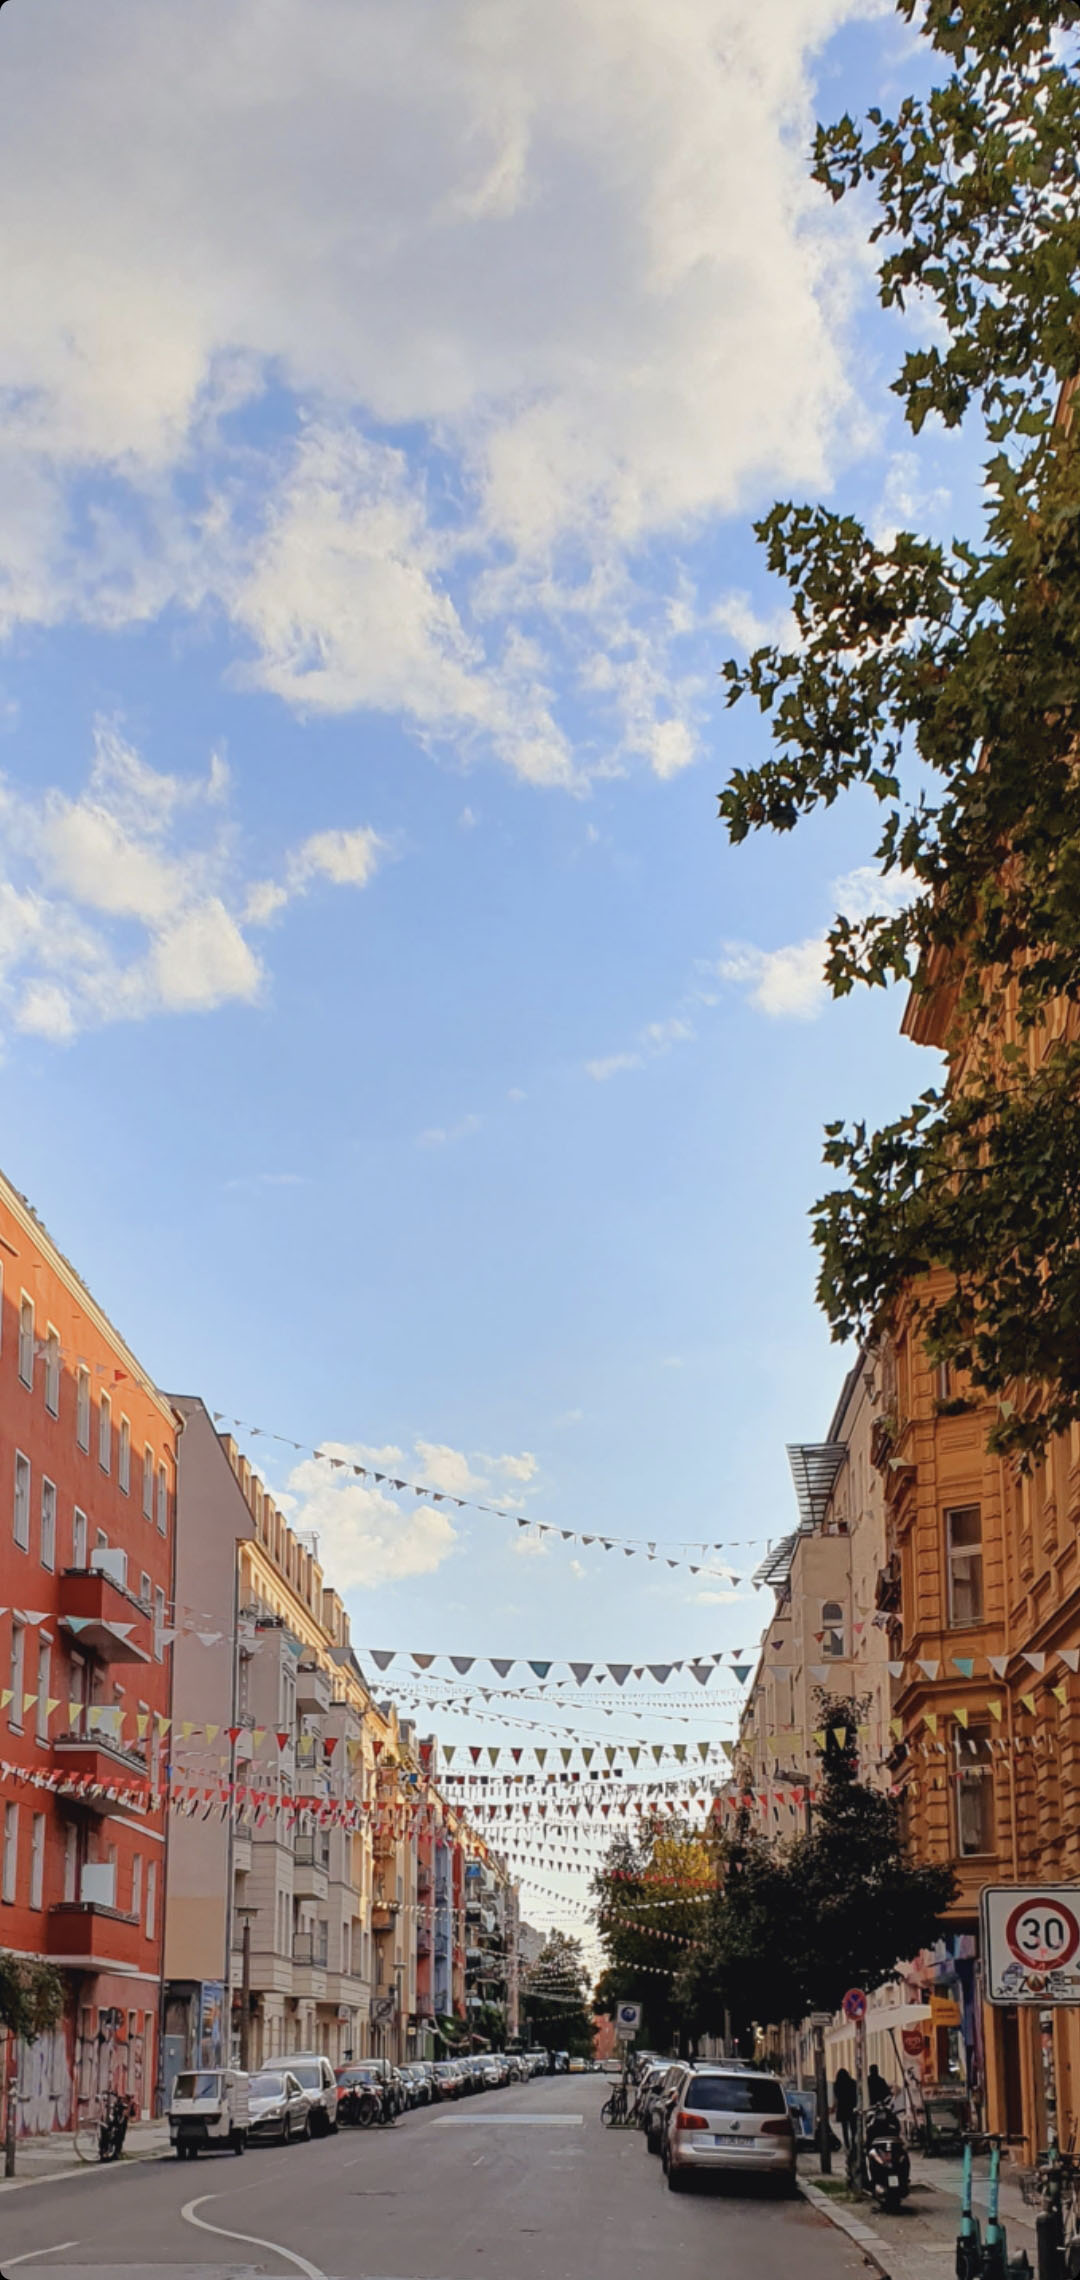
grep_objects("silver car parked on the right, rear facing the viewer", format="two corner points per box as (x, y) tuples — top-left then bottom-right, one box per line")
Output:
(663, 2066), (795, 2193)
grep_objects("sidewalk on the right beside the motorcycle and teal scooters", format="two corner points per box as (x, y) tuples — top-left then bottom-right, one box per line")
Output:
(800, 2152), (1034, 2280)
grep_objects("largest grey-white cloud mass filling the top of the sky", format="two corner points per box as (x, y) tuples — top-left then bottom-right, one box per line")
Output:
(0, 0), (870, 784)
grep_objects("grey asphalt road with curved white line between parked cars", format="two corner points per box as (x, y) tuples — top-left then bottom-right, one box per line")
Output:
(0, 2075), (866, 2280)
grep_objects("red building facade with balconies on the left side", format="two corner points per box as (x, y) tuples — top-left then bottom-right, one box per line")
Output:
(0, 1176), (178, 2134)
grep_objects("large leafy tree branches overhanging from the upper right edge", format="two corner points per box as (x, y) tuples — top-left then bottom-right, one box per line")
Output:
(720, 0), (1080, 1461)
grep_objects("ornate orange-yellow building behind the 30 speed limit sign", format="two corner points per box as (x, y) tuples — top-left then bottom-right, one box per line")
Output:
(875, 962), (1080, 2148)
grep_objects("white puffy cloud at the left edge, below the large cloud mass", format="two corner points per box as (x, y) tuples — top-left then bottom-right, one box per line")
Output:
(0, 725), (381, 1044)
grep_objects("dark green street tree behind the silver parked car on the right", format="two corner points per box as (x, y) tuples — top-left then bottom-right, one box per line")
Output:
(679, 1696), (957, 2038)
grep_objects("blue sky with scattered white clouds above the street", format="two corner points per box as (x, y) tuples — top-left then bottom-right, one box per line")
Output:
(0, 0), (973, 1833)
